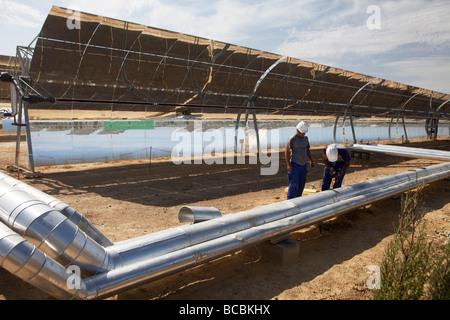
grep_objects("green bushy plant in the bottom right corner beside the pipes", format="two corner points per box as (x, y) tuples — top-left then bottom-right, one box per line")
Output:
(372, 185), (450, 300)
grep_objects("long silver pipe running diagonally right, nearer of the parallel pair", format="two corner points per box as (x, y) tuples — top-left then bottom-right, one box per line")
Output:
(86, 162), (450, 299)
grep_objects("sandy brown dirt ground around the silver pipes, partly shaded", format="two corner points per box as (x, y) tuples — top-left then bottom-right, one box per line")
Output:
(0, 111), (450, 300)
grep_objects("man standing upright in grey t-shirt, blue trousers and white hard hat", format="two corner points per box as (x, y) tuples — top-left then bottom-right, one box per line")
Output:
(285, 121), (314, 199)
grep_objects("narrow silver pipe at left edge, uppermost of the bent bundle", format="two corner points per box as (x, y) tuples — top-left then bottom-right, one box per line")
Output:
(0, 172), (113, 247)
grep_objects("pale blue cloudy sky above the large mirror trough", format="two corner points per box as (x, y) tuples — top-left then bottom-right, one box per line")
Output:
(0, 0), (450, 94)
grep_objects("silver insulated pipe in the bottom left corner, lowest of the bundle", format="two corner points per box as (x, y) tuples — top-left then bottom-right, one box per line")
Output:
(0, 222), (86, 299)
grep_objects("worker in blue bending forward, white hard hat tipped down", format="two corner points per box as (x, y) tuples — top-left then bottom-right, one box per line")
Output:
(322, 143), (351, 191)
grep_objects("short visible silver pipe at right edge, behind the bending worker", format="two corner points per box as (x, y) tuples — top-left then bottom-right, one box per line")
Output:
(347, 144), (450, 161)
